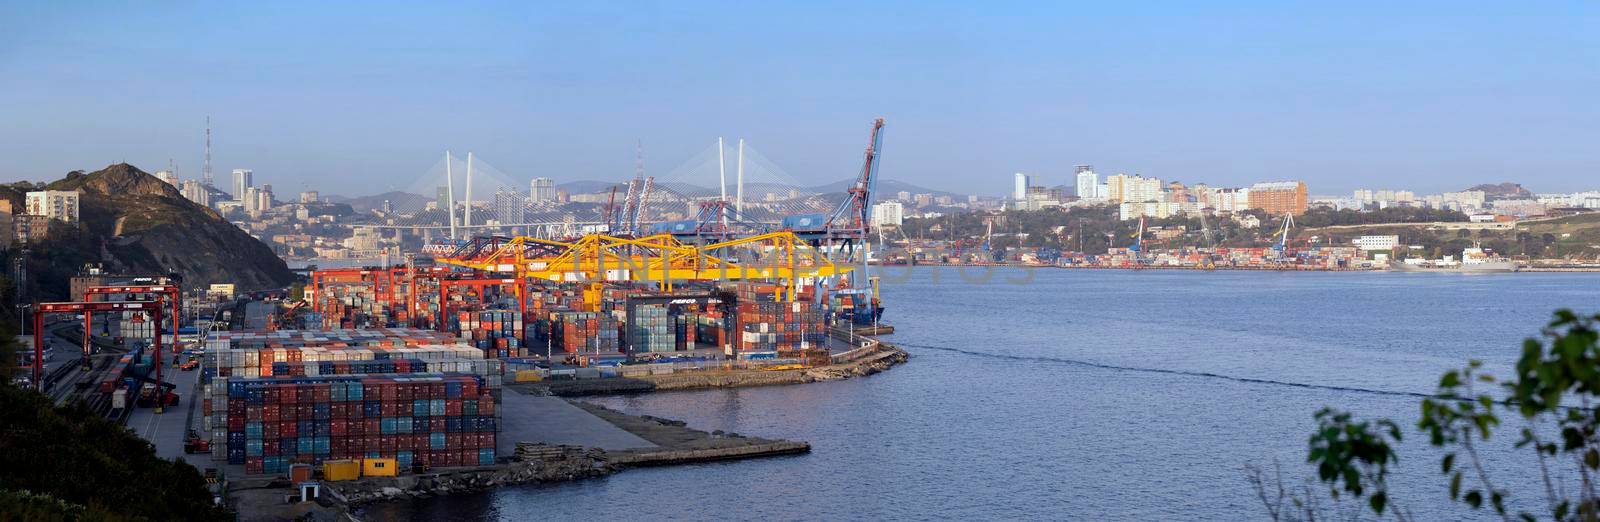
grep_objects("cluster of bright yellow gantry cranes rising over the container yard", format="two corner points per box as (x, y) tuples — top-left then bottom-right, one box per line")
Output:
(437, 231), (851, 299)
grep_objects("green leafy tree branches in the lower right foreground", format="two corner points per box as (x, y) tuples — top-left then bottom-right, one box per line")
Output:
(1251, 309), (1600, 520)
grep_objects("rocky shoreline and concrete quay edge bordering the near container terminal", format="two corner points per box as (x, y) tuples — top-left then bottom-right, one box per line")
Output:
(226, 337), (910, 520)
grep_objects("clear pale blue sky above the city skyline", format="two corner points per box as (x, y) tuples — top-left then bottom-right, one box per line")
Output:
(0, 2), (1600, 195)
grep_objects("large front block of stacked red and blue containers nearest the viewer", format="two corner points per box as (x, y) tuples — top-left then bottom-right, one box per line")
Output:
(211, 375), (499, 474)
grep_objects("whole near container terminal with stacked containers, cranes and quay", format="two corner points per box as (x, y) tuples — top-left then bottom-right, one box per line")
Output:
(12, 118), (904, 512)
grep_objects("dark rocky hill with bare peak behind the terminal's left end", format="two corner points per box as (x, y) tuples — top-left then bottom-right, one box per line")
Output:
(0, 163), (293, 298)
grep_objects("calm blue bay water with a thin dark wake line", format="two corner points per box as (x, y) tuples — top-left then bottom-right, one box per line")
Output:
(368, 267), (1600, 520)
